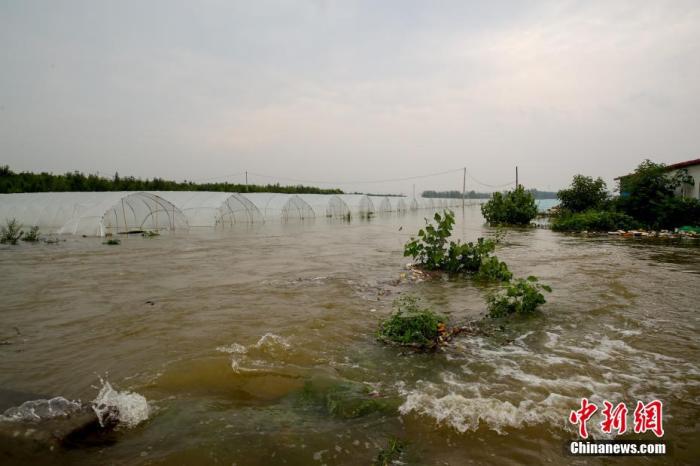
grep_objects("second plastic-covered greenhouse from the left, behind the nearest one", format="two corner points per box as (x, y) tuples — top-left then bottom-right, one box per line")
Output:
(152, 191), (263, 227)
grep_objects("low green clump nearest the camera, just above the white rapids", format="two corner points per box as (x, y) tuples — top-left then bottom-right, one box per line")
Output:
(377, 296), (447, 349)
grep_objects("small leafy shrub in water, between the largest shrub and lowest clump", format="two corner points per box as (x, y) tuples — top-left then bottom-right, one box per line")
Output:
(487, 276), (552, 318)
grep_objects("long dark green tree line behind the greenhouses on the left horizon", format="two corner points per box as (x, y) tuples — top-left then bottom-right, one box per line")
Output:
(0, 165), (343, 194)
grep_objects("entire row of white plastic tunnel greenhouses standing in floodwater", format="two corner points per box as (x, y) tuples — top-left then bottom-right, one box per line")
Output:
(0, 191), (474, 236)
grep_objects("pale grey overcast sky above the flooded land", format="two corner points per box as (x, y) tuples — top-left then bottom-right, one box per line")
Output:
(0, 0), (700, 194)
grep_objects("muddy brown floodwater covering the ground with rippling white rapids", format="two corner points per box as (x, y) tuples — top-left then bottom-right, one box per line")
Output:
(0, 206), (700, 466)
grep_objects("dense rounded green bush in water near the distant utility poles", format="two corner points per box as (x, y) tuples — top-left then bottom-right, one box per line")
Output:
(481, 186), (537, 225)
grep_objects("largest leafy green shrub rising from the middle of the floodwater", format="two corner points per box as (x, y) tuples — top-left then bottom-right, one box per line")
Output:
(404, 210), (512, 281)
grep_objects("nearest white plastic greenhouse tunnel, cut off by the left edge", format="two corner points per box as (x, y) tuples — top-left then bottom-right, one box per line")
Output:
(0, 192), (188, 236)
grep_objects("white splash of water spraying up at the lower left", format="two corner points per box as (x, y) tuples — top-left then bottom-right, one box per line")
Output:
(92, 378), (151, 427)
